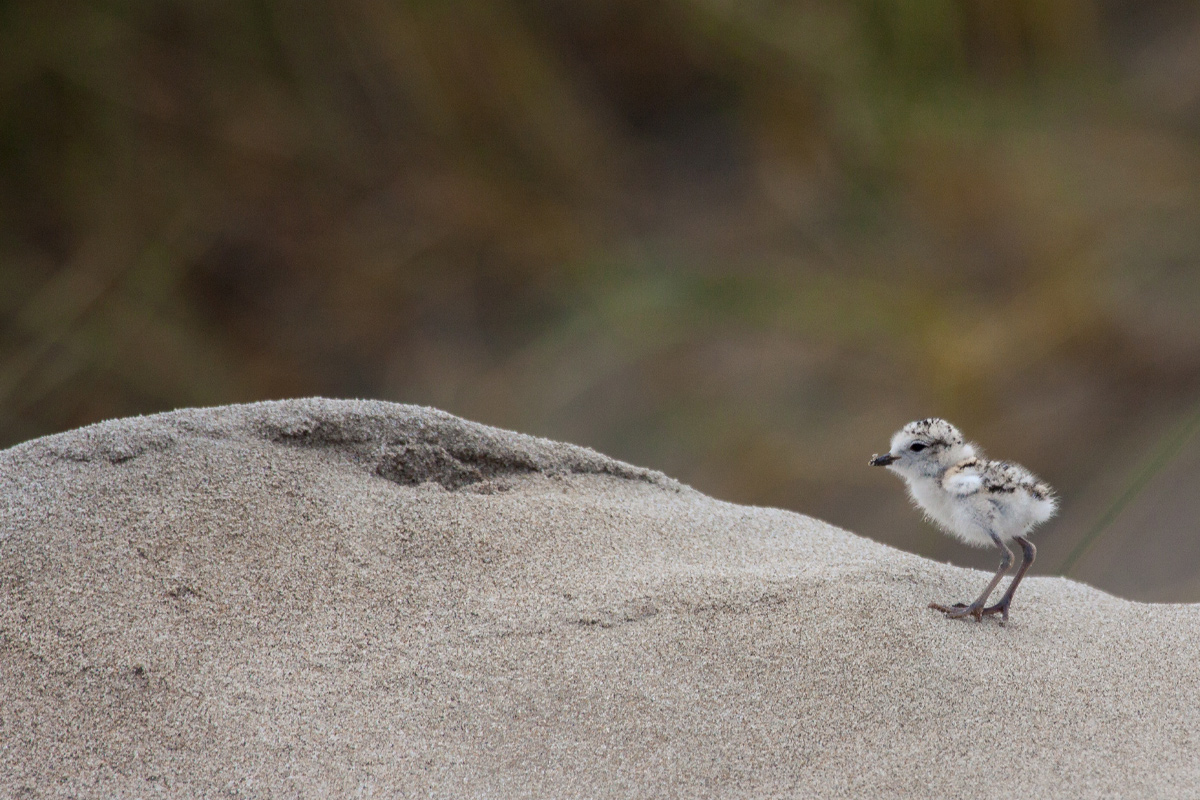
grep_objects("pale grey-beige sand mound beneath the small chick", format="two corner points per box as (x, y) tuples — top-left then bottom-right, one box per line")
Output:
(0, 401), (1200, 798)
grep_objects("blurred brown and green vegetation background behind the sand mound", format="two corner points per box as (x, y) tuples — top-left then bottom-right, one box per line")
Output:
(0, 0), (1200, 601)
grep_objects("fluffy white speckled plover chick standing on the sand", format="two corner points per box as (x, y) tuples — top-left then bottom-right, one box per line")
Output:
(870, 417), (1058, 621)
